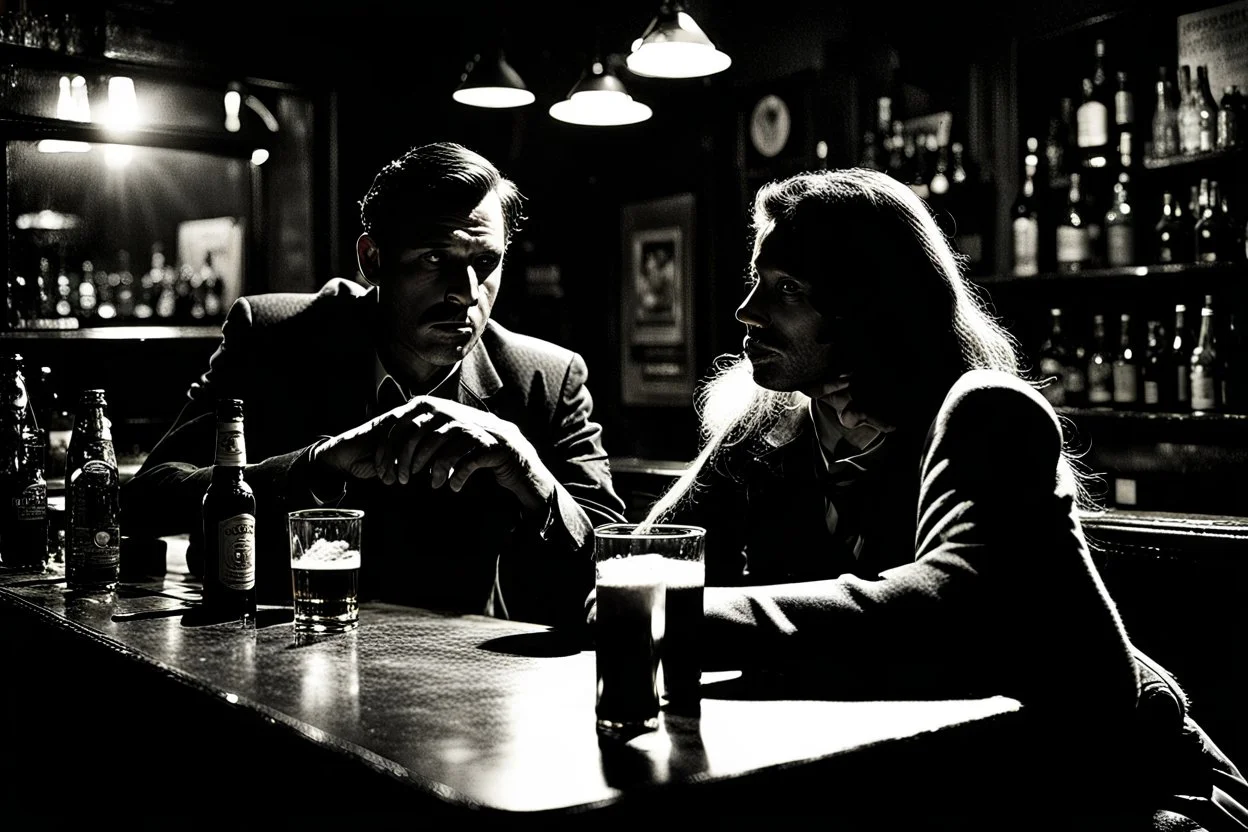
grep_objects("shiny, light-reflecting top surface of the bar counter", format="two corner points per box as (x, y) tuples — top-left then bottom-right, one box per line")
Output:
(0, 540), (1063, 818)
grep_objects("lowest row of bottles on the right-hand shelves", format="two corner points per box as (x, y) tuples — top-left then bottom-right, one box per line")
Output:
(1037, 294), (1248, 413)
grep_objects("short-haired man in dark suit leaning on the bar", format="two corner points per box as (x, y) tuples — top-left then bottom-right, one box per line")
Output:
(122, 143), (623, 625)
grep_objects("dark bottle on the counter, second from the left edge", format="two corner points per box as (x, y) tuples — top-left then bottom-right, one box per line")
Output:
(65, 389), (121, 591)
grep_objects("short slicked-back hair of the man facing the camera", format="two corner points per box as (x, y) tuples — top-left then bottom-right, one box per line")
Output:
(359, 142), (524, 247)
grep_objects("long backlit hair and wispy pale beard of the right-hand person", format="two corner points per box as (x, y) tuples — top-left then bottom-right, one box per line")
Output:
(646, 168), (1093, 523)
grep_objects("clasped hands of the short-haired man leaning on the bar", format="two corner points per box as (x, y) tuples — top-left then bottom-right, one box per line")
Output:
(313, 397), (554, 509)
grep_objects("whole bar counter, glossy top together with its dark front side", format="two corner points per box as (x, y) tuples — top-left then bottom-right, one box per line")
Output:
(0, 540), (1108, 828)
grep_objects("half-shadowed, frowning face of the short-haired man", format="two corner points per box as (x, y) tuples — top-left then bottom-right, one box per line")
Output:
(378, 191), (507, 380)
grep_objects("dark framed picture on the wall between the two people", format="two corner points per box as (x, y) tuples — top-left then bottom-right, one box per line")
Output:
(620, 193), (694, 407)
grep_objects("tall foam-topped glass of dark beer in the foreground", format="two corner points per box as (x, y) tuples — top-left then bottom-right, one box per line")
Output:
(594, 523), (706, 728)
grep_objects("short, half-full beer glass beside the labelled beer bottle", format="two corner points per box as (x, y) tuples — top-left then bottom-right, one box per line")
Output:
(287, 509), (364, 635)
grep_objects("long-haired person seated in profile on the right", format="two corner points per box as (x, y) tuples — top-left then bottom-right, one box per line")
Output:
(651, 170), (1242, 828)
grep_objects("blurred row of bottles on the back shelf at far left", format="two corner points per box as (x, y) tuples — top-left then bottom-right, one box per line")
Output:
(6, 243), (226, 329)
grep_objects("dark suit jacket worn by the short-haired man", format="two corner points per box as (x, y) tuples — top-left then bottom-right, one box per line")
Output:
(122, 278), (623, 624)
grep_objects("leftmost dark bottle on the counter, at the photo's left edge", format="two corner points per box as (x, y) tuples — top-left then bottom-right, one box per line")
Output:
(0, 353), (47, 570)
